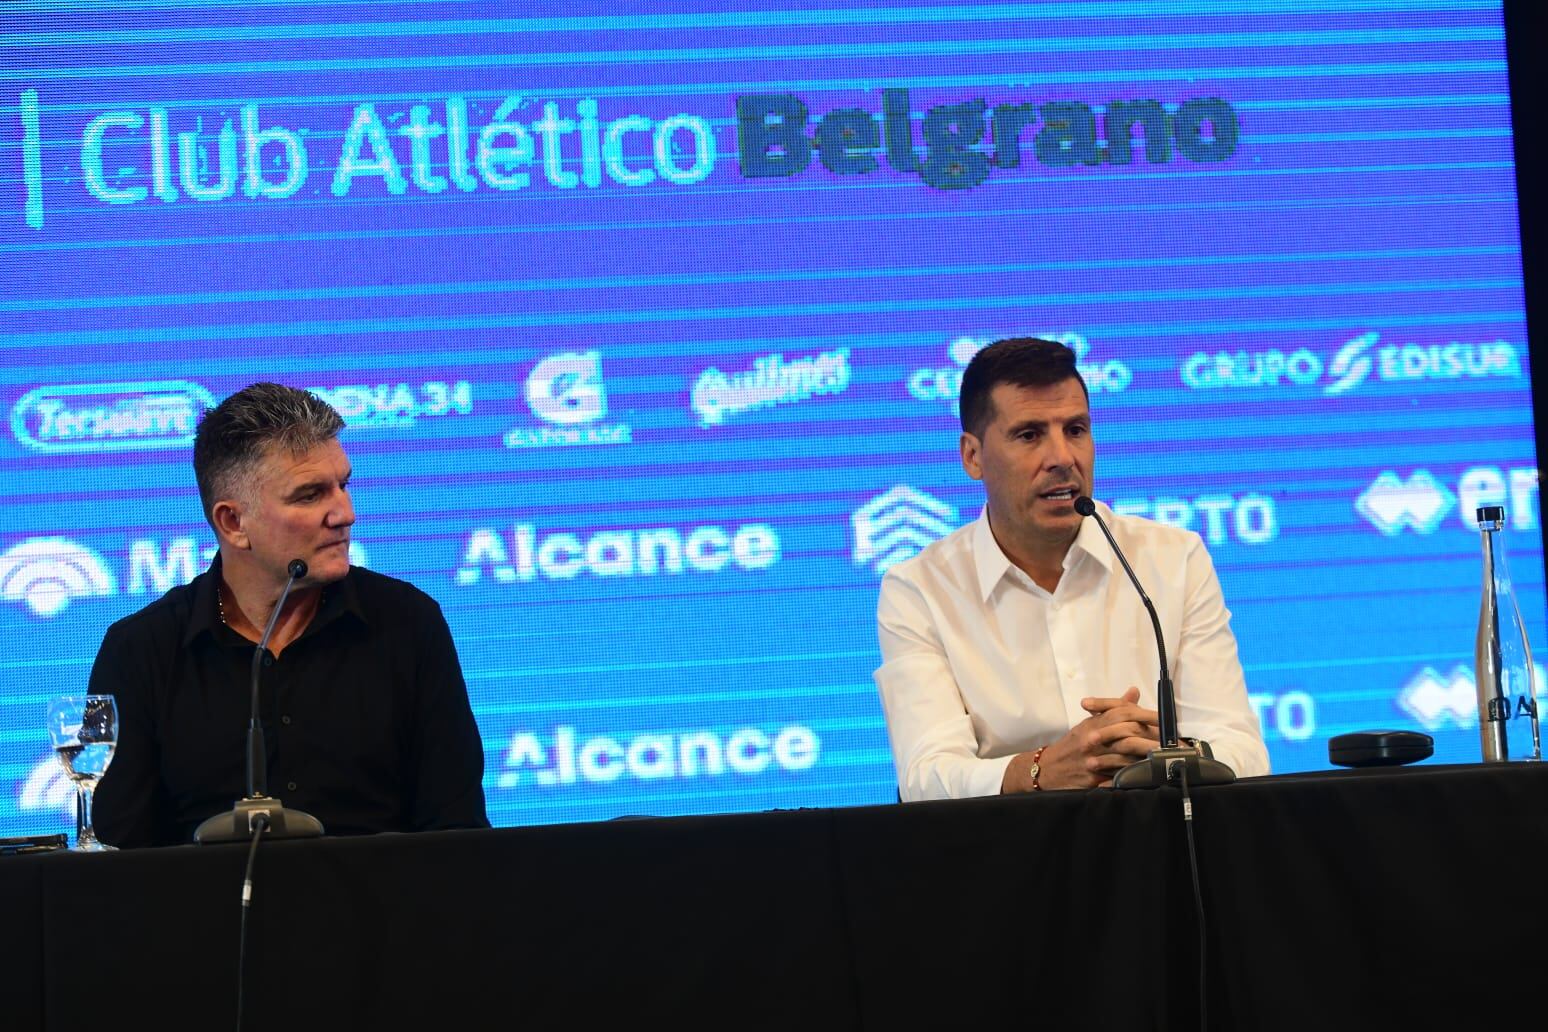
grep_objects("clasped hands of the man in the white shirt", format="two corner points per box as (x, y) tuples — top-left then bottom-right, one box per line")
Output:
(1000, 689), (1161, 795)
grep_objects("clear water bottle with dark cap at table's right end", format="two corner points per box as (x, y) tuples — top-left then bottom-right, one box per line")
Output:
(1474, 506), (1542, 763)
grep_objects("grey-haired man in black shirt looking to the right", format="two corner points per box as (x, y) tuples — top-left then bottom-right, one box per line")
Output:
(90, 384), (489, 846)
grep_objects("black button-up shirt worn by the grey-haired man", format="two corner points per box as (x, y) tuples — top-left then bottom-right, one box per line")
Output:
(90, 559), (489, 846)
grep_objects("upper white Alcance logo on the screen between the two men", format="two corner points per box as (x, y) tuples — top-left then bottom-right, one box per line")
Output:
(455, 523), (780, 586)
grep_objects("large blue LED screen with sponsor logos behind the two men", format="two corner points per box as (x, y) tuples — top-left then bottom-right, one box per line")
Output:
(0, 0), (1548, 834)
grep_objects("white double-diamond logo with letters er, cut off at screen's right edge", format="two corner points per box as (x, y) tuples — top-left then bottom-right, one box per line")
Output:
(1355, 466), (1539, 537)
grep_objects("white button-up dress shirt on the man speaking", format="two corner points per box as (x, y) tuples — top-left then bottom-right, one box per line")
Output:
(876, 503), (1268, 801)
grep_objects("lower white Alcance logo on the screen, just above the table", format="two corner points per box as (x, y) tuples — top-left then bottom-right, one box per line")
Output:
(495, 724), (822, 789)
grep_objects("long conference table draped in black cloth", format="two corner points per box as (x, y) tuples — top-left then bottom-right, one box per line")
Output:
(0, 764), (1548, 1032)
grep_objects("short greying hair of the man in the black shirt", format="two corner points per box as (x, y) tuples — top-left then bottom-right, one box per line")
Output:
(194, 384), (344, 525)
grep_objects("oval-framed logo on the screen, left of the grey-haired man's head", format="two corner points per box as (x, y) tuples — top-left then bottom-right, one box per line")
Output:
(11, 381), (215, 453)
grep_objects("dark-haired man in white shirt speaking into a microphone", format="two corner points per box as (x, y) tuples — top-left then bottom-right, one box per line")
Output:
(876, 337), (1268, 801)
